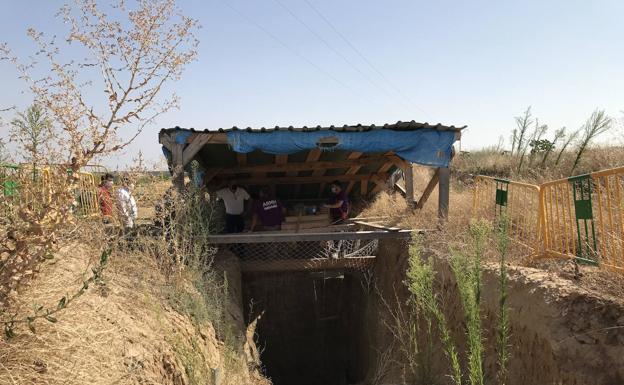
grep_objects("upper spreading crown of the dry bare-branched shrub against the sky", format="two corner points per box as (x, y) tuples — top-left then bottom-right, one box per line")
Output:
(0, 0), (198, 171)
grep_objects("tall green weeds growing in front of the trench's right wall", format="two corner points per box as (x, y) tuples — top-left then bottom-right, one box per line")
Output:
(393, 218), (510, 385)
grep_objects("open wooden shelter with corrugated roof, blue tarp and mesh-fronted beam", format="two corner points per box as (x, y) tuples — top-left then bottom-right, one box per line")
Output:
(159, 121), (465, 271)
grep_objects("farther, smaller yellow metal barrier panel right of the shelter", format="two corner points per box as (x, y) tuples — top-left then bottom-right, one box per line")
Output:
(472, 176), (541, 256)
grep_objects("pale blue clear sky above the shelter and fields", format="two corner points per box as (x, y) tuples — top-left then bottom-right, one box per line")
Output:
(0, 0), (624, 169)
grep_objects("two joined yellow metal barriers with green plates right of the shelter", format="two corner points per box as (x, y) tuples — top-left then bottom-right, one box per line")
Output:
(473, 167), (624, 273)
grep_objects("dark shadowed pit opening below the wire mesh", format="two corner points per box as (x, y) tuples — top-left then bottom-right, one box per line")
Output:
(243, 271), (370, 385)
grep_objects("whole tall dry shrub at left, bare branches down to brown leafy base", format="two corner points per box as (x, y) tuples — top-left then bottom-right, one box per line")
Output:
(0, 0), (198, 307)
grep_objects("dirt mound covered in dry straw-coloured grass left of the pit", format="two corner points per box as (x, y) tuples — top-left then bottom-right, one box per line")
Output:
(0, 245), (266, 385)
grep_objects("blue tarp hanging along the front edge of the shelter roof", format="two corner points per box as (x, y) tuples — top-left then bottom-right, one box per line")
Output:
(227, 129), (455, 167)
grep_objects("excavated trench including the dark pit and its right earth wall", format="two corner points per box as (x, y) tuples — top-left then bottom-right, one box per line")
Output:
(239, 240), (624, 385)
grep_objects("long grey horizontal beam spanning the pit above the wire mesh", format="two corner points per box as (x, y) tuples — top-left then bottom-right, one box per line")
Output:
(206, 230), (412, 244)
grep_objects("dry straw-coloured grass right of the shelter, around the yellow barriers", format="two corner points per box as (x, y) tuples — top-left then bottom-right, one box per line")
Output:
(360, 154), (624, 301)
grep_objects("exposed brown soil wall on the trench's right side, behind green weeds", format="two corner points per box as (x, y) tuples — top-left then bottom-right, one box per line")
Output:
(368, 241), (624, 385)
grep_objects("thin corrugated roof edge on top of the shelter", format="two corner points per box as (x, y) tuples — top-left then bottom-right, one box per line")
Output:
(161, 120), (467, 132)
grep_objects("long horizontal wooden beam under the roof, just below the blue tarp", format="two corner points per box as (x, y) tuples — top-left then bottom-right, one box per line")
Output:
(219, 155), (393, 176)
